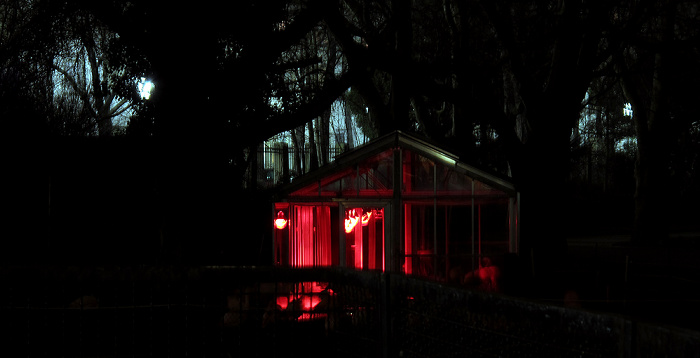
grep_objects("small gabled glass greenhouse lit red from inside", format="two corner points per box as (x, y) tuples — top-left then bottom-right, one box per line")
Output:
(273, 132), (519, 281)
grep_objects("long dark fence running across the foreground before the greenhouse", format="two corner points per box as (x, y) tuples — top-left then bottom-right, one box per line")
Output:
(0, 267), (700, 357)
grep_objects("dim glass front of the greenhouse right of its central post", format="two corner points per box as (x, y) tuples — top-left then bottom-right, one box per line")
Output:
(402, 150), (512, 282)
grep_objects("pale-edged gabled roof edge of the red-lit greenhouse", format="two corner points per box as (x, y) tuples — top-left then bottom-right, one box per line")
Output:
(281, 131), (516, 200)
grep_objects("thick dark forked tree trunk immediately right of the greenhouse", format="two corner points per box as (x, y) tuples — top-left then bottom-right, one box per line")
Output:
(490, 1), (599, 286)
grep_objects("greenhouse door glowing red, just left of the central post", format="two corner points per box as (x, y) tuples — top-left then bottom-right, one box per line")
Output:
(340, 204), (387, 271)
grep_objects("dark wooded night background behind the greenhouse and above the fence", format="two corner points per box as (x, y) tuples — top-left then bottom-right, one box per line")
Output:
(0, 0), (700, 330)
